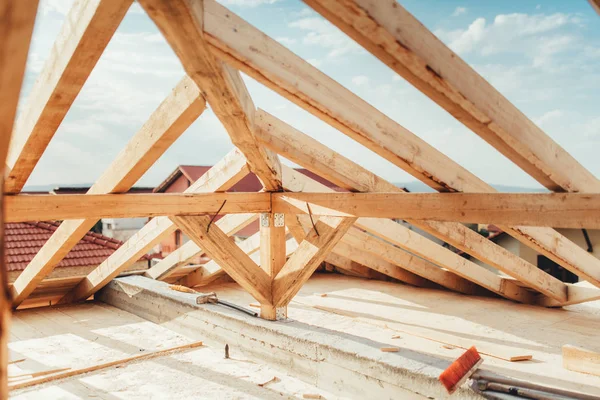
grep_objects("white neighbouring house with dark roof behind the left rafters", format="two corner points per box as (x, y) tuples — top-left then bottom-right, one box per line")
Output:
(50, 186), (154, 241)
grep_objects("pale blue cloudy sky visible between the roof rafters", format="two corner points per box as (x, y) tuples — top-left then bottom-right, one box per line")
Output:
(21, 0), (600, 188)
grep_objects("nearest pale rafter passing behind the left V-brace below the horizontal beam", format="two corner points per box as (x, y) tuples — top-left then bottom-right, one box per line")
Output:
(144, 214), (257, 280)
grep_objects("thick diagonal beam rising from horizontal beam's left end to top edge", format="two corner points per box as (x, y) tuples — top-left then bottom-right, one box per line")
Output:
(2, 0), (132, 193)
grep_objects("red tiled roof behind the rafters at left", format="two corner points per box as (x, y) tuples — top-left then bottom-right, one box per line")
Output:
(4, 222), (148, 271)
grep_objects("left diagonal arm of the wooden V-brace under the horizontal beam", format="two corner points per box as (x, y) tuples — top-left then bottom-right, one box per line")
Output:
(169, 216), (272, 304)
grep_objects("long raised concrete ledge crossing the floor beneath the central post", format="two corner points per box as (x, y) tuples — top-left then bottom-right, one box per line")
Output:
(96, 277), (488, 399)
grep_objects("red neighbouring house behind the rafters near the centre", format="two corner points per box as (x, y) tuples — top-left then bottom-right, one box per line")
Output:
(154, 165), (345, 262)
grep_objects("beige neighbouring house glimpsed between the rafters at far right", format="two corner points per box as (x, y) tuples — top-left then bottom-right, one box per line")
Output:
(473, 225), (600, 283)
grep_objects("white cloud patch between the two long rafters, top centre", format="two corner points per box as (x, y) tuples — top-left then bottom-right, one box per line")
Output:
(289, 17), (362, 58)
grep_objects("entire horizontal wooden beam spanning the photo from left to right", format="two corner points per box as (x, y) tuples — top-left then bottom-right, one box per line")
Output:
(6, 192), (600, 229)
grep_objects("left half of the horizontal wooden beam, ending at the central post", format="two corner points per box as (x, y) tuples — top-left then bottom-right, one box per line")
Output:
(6, 192), (271, 222)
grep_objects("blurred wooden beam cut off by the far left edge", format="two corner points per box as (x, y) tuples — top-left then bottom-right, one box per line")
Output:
(0, 0), (38, 399)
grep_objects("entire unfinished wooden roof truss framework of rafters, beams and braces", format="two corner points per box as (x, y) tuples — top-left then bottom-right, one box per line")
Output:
(0, 0), (600, 319)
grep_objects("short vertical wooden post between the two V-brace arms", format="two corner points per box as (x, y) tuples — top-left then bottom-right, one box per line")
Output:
(260, 213), (287, 321)
